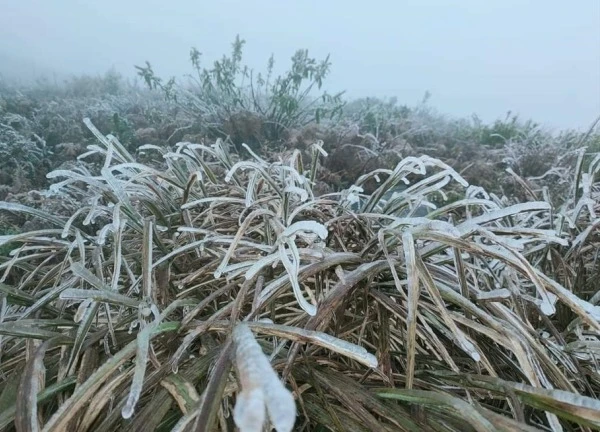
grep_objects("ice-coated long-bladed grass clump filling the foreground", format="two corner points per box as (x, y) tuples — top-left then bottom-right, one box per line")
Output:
(0, 116), (600, 432)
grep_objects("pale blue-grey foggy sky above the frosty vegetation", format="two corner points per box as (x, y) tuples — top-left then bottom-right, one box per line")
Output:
(0, 0), (600, 128)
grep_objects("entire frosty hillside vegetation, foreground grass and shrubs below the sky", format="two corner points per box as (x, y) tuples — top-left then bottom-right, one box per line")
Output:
(0, 39), (600, 432)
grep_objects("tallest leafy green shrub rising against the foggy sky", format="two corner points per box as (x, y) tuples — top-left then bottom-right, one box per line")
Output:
(136, 36), (343, 146)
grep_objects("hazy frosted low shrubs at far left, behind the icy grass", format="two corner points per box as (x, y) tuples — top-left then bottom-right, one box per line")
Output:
(0, 80), (190, 188)
